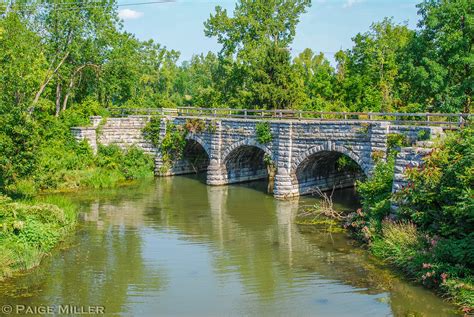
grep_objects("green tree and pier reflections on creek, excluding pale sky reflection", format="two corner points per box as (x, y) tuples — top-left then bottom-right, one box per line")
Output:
(0, 177), (454, 316)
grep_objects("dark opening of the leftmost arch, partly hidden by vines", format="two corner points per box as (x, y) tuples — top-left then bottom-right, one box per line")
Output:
(172, 139), (210, 175)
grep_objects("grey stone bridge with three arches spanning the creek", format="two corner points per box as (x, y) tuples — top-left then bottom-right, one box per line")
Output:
(72, 110), (443, 199)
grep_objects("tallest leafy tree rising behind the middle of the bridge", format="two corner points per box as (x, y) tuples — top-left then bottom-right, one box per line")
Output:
(204, 0), (311, 108)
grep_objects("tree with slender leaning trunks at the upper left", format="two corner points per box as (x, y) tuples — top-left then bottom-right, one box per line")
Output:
(29, 0), (118, 116)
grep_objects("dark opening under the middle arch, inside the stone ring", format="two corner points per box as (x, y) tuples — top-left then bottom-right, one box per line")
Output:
(224, 145), (275, 192)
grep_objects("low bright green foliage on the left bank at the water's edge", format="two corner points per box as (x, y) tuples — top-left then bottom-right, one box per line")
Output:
(0, 196), (76, 280)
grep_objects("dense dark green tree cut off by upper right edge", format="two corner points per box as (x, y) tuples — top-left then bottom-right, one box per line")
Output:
(406, 0), (474, 113)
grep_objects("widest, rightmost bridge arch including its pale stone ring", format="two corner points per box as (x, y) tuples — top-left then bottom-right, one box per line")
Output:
(292, 143), (368, 195)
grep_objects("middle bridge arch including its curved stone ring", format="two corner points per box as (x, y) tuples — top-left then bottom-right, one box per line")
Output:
(222, 138), (274, 184)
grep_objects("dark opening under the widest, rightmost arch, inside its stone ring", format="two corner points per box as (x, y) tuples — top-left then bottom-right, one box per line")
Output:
(294, 151), (366, 195)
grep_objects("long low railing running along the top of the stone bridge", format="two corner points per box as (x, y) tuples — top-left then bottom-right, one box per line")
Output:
(108, 107), (473, 128)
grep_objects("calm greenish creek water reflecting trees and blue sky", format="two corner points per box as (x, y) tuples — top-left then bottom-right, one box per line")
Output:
(0, 176), (456, 317)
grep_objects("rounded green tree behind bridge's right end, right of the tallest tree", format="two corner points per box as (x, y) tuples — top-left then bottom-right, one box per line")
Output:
(337, 18), (412, 111)
